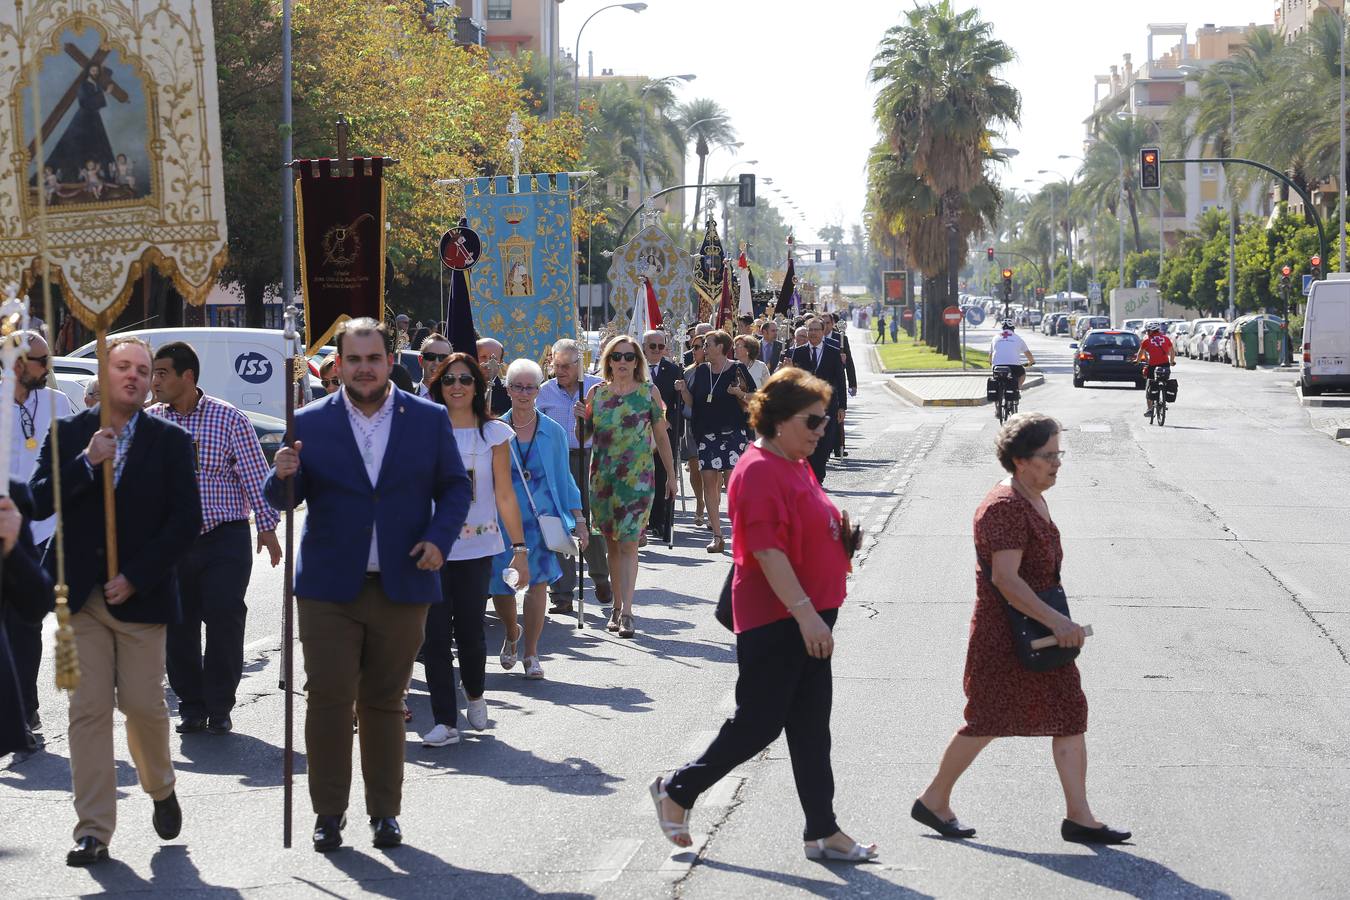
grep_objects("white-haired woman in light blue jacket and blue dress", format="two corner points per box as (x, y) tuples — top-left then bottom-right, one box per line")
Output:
(489, 359), (590, 680)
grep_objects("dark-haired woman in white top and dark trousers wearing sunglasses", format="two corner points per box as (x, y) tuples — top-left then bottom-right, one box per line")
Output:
(423, 354), (529, 748)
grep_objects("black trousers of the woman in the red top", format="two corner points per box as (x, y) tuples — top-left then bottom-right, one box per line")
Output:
(666, 610), (840, 841)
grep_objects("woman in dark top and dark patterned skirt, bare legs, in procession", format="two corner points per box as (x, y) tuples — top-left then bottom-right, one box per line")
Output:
(680, 331), (755, 553)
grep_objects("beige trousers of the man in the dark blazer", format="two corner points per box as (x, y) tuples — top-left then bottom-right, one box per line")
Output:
(70, 587), (174, 843)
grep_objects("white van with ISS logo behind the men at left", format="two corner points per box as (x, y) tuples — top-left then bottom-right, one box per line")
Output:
(70, 328), (321, 418)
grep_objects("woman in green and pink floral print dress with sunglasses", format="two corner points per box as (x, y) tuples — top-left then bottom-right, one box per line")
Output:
(586, 335), (679, 637)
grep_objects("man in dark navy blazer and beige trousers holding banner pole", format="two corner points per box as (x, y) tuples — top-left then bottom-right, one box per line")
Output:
(30, 337), (201, 866)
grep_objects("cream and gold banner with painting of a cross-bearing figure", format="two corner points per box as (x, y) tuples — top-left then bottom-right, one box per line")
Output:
(0, 0), (225, 329)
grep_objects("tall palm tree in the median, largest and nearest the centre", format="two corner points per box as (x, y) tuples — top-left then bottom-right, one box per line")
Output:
(871, 0), (1021, 356)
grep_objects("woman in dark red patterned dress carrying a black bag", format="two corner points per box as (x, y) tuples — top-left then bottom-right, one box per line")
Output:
(910, 413), (1130, 843)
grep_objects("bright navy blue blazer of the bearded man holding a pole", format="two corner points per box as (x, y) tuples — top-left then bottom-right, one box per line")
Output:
(263, 386), (471, 603)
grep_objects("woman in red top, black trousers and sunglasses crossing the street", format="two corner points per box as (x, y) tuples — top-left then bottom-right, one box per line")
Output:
(649, 367), (876, 862)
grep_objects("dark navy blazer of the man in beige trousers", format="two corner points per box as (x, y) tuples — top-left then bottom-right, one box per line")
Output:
(28, 406), (201, 625)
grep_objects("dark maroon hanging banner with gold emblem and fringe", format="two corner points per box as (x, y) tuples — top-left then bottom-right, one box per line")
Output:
(292, 157), (385, 355)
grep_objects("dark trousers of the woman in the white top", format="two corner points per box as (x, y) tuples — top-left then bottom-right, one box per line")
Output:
(423, 556), (494, 729)
